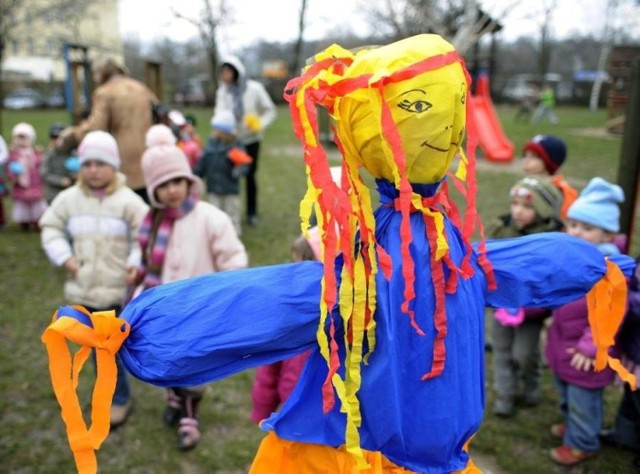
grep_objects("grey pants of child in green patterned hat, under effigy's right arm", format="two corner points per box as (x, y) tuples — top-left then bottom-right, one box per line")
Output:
(491, 319), (544, 399)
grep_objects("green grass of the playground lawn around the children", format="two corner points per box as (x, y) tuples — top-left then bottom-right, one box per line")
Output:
(0, 107), (640, 474)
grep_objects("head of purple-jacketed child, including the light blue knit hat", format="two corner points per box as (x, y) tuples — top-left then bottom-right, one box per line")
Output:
(567, 178), (624, 255)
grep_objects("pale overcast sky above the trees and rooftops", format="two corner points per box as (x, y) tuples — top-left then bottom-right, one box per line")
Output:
(118, 0), (640, 54)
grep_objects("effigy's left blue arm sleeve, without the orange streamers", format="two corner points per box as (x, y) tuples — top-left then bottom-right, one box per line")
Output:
(120, 261), (323, 386)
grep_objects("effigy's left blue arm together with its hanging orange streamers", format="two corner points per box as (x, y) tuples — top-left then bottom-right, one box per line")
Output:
(42, 262), (323, 473)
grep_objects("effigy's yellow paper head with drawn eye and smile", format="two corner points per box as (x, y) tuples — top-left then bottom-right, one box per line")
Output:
(334, 35), (467, 183)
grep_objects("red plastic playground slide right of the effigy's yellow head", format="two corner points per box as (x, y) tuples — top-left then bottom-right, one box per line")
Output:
(471, 74), (515, 163)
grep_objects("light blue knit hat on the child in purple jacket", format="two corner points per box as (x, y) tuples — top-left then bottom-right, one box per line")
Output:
(567, 178), (624, 233)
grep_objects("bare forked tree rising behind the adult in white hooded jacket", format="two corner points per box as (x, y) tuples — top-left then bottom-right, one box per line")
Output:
(172, 0), (233, 105)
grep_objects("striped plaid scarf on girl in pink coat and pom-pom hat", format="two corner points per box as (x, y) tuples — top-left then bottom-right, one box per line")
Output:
(138, 196), (197, 290)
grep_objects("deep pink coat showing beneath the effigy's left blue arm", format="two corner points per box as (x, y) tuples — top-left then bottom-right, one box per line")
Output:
(251, 351), (310, 423)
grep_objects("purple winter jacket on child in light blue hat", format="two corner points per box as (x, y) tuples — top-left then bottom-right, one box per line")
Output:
(545, 298), (615, 388)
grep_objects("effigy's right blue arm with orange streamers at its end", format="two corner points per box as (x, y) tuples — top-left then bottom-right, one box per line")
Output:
(476, 233), (636, 387)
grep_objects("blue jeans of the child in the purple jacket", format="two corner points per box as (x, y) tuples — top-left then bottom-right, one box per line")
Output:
(555, 377), (604, 452)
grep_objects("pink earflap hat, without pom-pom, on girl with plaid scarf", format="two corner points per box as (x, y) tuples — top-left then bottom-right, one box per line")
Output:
(142, 145), (202, 208)
